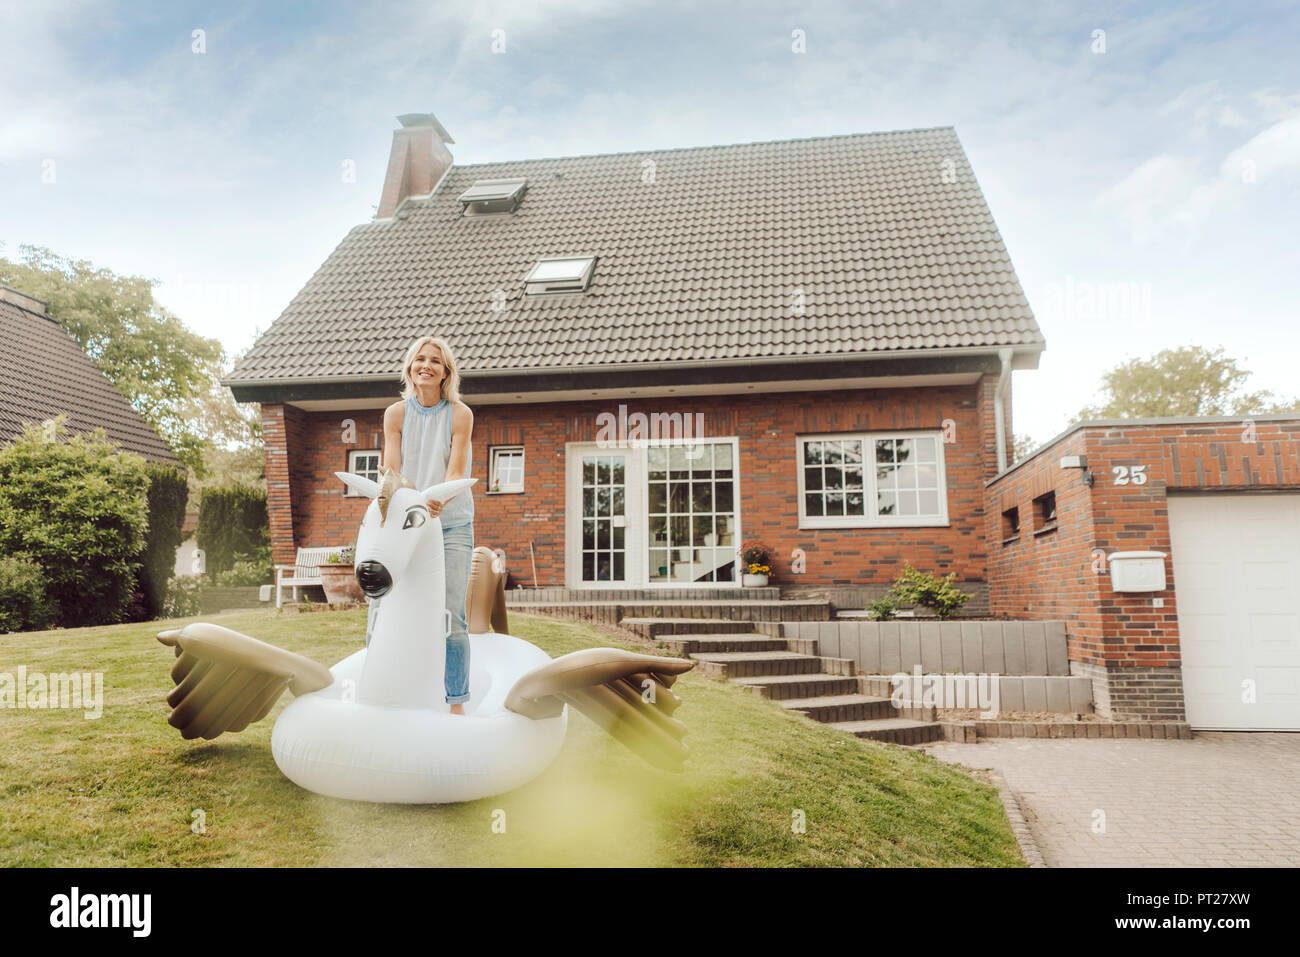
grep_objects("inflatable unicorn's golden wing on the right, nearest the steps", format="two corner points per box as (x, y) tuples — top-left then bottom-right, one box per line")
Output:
(506, 648), (696, 771)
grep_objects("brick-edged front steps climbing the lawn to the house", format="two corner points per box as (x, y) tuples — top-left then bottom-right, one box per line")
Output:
(621, 618), (944, 745)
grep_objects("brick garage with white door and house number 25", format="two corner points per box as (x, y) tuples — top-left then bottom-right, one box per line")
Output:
(985, 413), (1300, 731)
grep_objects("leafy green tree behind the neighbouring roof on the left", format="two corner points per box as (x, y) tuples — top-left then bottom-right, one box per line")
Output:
(0, 246), (226, 475)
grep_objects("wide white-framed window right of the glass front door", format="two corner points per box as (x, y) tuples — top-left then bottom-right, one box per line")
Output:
(796, 429), (948, 528)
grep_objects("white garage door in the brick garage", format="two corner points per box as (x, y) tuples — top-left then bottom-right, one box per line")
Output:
(1169, 493), (1300, 731)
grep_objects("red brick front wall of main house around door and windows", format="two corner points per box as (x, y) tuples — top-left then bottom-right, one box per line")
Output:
(263, 376), (1010, 586)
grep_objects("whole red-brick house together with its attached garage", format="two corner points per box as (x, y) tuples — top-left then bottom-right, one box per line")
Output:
(229, 114), (1300, 740)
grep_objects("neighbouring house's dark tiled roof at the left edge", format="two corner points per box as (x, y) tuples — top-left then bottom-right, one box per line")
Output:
(0, 287), (178, 464)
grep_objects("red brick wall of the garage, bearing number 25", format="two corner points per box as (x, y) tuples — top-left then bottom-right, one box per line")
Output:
(985, 416), (1300, 667)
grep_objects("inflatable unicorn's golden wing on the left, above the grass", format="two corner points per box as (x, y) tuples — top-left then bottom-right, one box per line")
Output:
(159, 622), (334, 741)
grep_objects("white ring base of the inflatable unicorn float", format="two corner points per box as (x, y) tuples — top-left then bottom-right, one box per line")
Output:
(270, 633), (568, 804)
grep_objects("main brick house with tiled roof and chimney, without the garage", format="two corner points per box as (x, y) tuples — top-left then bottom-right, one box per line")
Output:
(220, 114), (1044, 610)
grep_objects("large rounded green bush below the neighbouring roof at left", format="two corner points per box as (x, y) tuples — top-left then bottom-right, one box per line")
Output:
(0, 417), (148, 627)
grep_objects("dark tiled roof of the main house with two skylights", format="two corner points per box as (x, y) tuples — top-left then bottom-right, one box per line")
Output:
(230, 127), (1044, 382)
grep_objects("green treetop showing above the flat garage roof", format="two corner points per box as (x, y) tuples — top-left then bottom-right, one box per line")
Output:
(1070, 346), (1300, 424)
